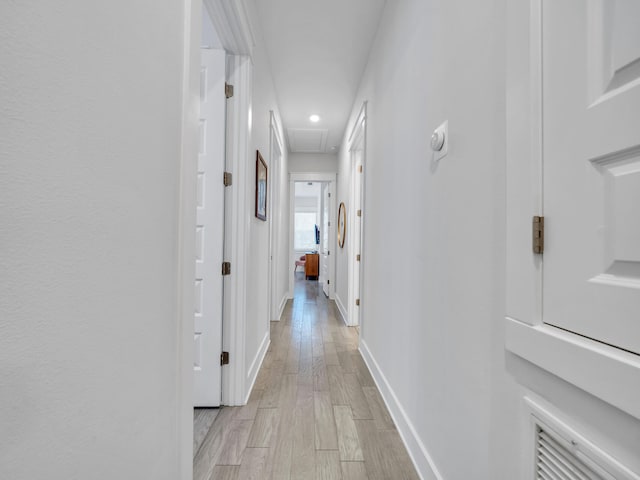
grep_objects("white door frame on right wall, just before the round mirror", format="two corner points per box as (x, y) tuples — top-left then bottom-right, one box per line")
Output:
(347, 102), (367, 326)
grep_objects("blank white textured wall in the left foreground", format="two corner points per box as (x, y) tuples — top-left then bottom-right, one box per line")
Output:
(0, 0), (192, 480)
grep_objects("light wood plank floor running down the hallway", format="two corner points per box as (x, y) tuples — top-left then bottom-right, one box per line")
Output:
(193, 274), (419, 480)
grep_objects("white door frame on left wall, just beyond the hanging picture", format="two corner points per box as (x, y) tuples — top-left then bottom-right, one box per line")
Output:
(269, 111), (284, 320)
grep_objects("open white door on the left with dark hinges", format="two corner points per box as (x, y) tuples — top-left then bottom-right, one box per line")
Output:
(193, 48), (226, 407)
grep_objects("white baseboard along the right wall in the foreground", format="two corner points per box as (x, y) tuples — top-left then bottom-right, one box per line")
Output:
(359, 339), (443, 480)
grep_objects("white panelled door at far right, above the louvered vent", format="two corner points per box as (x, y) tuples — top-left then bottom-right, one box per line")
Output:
(542, 0), (640, 354)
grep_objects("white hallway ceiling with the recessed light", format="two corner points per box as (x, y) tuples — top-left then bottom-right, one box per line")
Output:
(255, 0), (385, 153)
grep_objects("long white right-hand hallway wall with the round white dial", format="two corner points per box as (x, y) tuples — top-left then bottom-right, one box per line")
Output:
(336, 0), (519, 480)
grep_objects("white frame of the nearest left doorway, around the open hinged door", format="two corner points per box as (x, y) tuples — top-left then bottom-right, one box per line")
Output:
(175, 0), (255, 472)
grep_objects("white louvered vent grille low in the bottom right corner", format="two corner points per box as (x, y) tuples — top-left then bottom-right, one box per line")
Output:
(536, 426), (605, 480)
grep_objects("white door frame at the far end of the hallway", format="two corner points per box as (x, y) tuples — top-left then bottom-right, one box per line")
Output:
(287, 172), (337, 300)
